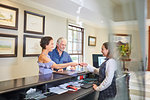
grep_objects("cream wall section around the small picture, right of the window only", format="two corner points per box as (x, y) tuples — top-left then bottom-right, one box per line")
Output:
(84, 25), (108, 65)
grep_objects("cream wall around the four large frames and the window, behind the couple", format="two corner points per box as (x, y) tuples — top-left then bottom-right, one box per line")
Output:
(0, 0), (107, 81)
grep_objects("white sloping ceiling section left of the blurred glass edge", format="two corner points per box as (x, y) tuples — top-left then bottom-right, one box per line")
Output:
(30, 0), (103, 24)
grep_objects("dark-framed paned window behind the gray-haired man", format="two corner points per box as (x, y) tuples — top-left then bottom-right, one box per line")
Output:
(68, 25), (84, 63)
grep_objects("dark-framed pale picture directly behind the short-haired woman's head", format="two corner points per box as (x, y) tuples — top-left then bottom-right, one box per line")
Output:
(23, 35), (42, 57)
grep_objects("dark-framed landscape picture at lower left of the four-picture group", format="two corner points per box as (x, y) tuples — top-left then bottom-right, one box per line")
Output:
(0, 34), (18, 57)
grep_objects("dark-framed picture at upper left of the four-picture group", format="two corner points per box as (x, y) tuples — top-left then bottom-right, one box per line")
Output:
(0, 4), (18, 30)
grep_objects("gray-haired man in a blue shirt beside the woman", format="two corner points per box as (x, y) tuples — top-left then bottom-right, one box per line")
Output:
(48, 37), (72, 71)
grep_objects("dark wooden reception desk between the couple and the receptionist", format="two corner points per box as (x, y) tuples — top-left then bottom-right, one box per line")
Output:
(0, 71), (129, 100)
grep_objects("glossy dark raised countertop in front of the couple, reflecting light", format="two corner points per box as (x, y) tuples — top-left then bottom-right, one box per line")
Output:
(0, 73), (70, 94)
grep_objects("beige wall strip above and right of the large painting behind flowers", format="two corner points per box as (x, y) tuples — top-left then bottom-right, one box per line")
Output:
(113, 25), (141, 60)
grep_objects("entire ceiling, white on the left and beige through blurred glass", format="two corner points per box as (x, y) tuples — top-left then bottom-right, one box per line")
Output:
(10, 0), (149, 25)
